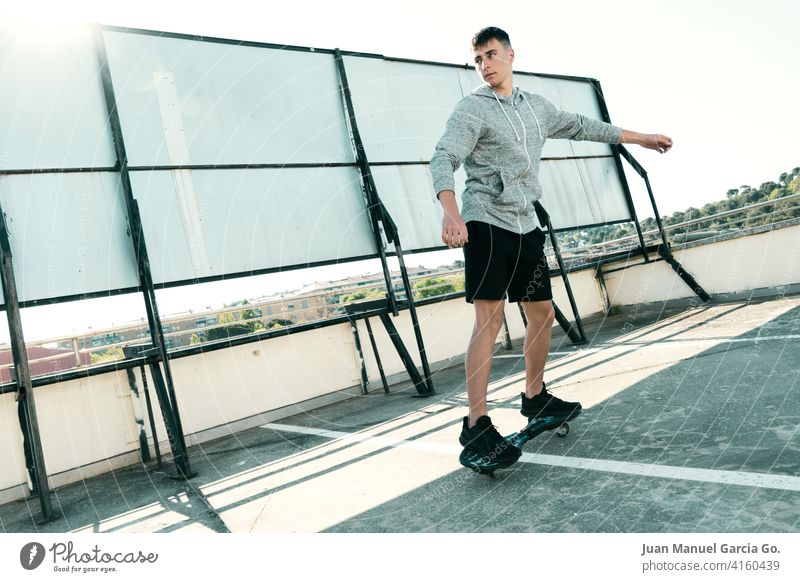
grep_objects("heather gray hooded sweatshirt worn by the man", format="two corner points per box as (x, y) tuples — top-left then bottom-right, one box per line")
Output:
(431, 85), (622, 234)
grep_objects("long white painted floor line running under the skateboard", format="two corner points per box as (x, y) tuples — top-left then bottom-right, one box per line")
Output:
(261, 423), (800, 491)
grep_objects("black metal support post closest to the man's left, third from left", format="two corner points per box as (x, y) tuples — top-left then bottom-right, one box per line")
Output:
(334, 49), (434, 396)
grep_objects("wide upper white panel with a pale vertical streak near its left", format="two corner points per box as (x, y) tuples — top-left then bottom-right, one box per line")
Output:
(104, 31), (353, 166)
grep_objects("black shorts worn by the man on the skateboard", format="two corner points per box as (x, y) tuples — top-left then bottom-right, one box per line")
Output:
(464, 220), (553, 303)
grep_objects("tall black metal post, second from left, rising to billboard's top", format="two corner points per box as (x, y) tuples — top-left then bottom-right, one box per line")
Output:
(94, 26), (195, 479)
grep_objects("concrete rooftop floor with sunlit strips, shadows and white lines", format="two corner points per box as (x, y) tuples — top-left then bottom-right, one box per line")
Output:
(0, 295), (800, 533)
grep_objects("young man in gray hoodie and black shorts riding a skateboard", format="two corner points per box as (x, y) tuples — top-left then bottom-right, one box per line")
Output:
(431, 27), (672, 466)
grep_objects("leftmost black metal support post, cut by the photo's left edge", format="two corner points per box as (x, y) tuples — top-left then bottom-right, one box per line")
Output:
(0, 206), (59, 523)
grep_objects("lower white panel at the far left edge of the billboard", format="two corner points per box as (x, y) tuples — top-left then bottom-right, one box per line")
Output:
(0, 172), (138, 301)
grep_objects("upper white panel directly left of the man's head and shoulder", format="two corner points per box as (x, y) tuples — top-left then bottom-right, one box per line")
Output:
(344, 57), (464, 163)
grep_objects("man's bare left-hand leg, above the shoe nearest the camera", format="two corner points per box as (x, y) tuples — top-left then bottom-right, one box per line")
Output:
(466, 299), (505, 428)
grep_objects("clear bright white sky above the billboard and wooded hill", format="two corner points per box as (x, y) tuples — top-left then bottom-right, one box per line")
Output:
(0, 0), (800, 339)
